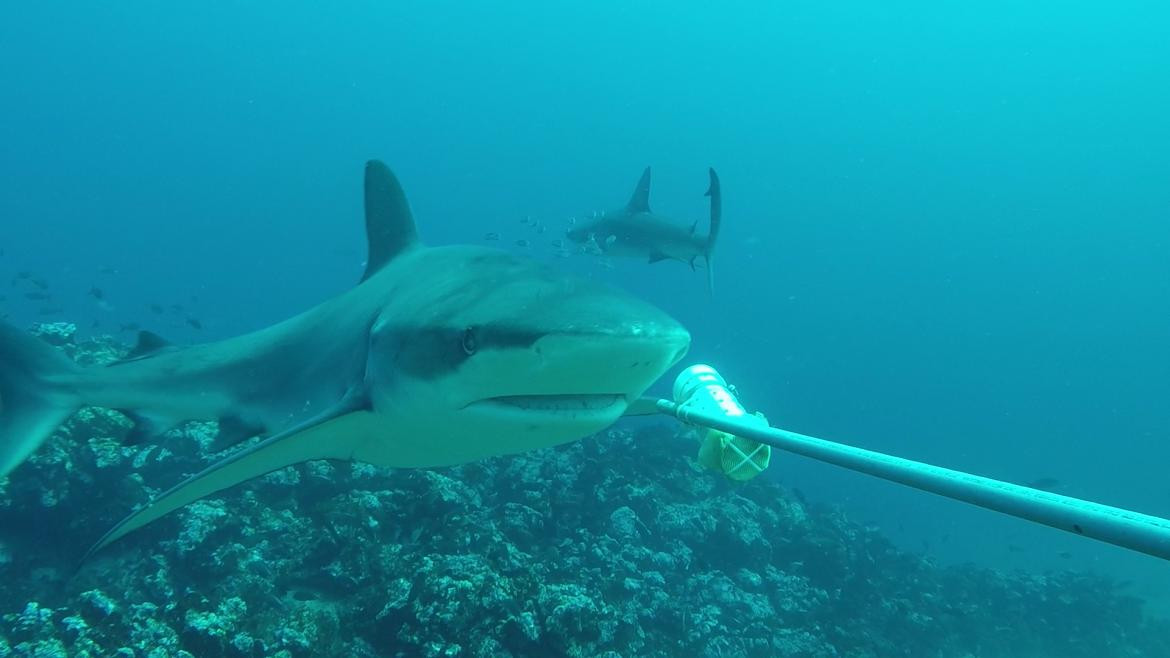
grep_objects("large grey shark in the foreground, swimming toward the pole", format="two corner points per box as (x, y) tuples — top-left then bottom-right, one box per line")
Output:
(0, 162), (690, 553)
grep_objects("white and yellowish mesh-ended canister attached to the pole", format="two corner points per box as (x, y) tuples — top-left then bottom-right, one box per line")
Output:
(674, 365), (772, 481)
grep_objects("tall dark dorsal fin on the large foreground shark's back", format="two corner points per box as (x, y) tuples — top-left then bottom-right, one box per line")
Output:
(362, 160), (419, 281)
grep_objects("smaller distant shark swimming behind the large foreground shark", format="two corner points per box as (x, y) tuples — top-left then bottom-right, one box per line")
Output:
(565, 167), (723, 290)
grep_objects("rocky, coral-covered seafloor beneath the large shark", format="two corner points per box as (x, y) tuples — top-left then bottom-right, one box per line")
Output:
(0, 324), (1170, 658)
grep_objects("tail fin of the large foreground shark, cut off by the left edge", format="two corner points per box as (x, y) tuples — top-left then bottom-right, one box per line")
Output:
(0, 323), (81, 478)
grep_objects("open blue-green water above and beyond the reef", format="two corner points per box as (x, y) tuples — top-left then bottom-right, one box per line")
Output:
(0, 1), (1170, 604)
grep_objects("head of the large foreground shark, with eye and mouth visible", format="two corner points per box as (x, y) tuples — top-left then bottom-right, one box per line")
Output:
(367, 246), (690, 466)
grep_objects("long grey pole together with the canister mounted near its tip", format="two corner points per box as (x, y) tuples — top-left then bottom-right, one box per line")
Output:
(631, 365), (1170, 560)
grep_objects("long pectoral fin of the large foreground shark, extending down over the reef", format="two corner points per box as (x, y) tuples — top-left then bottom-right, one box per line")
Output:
(82, 410), (374, 554)
